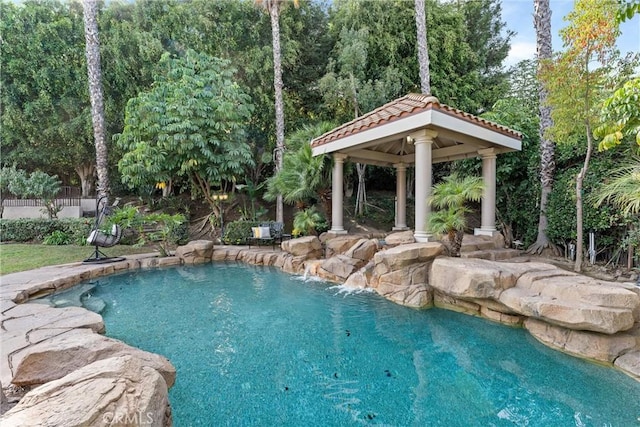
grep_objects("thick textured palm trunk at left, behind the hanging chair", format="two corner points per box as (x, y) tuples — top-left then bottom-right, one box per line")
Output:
(83, 0), (109, 200)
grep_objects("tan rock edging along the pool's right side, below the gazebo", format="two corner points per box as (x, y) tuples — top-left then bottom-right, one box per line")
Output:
(212, 237), (640, 381)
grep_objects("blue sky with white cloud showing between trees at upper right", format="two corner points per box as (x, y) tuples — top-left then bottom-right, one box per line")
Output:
(502, 0), (640, 68)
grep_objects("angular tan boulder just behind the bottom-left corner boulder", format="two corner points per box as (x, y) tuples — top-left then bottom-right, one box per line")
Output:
(10, 329), (176, 387)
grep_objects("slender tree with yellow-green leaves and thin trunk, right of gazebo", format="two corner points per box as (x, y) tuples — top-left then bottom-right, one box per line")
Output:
(542, 0), (619, 271)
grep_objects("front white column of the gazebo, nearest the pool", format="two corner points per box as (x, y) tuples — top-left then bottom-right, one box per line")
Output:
(411, 129), (438, 242)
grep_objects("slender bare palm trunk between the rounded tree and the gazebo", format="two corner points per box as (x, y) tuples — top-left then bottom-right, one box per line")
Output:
(269, 1), (285, 222)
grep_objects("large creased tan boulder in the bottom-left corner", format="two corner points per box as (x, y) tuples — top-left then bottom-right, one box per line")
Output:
(0, 356), (171, 427)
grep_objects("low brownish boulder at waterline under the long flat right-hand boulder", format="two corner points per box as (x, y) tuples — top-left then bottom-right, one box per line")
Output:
(524, 318), (637, 363)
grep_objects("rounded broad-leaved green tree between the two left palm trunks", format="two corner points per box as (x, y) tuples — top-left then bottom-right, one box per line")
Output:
(116, 50), (253, 215)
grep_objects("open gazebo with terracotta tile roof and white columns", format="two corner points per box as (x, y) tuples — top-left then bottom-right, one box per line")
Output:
(311, 93), (522, 242)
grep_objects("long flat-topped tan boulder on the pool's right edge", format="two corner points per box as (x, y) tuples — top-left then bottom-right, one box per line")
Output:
(430, 255), (640, 334)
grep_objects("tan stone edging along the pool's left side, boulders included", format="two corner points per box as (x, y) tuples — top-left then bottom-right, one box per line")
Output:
(0, 254), (182, 426)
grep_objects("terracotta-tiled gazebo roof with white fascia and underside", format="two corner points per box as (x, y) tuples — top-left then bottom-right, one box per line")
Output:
(311, 93), (522, 166)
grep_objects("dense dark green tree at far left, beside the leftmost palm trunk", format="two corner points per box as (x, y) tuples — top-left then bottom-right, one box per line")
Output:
(0, 0), (95, 196)
